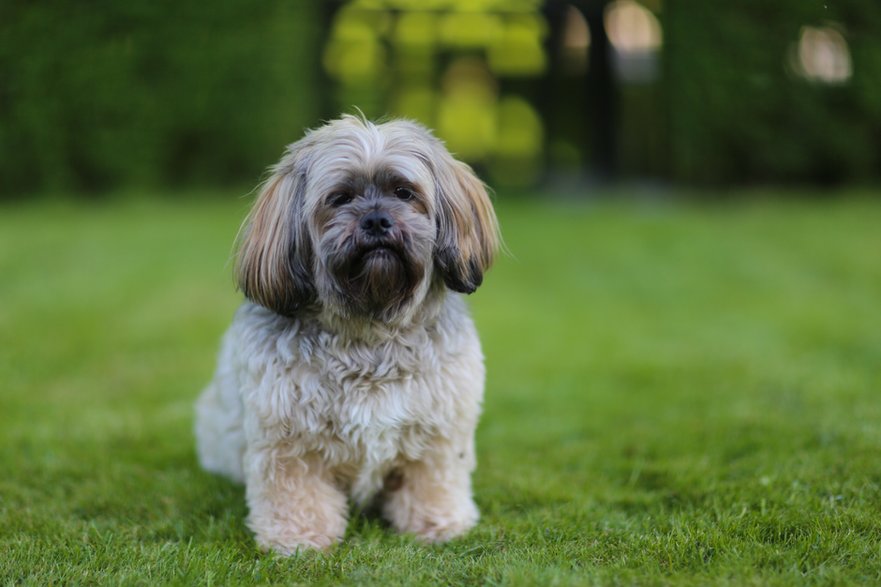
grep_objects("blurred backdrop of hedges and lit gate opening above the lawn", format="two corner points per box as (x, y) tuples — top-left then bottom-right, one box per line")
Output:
(0, 0), (881, 198)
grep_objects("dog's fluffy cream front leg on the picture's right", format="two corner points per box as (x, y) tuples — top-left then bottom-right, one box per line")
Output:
(383, 438), (479, 542)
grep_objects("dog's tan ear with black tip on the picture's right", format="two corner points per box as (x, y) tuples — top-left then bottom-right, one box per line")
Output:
(432, 145), (499, 294)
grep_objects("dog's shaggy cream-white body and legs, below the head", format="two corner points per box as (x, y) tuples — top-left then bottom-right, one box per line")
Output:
(196, 294), (484, 553)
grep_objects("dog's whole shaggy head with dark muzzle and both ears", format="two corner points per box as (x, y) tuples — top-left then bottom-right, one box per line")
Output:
(236, 117), (498, 321)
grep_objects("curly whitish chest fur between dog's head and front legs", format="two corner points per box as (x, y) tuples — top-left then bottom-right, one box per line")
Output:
(234, 300), (483, 501)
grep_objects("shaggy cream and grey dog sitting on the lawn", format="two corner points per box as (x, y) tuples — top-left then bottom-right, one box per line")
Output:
(195, 116), (500, 554)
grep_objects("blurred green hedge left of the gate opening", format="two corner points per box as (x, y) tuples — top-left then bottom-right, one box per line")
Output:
(0, 0), (317, 196)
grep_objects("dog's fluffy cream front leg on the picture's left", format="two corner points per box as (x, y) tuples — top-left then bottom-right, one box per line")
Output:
(245, 447), (347, 554)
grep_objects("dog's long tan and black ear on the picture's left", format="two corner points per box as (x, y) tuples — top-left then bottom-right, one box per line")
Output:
(235, 141), (316, 316)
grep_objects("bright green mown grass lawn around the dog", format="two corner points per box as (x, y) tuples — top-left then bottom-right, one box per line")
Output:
(0, 194), (881, 585)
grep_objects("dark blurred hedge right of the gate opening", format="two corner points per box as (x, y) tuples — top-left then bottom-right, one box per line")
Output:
(663, 0), (881, 183)
